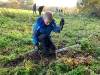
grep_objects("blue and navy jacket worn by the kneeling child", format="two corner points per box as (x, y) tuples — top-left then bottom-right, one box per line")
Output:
(32, 17), (60, 45)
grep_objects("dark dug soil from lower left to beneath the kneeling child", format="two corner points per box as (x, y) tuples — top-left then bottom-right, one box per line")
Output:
(5, 51), (56, 67)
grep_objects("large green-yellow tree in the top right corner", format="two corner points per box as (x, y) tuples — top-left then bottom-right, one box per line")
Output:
(77, 0), (100, 18)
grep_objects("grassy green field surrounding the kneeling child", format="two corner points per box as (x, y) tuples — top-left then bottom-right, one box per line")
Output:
(0, 8), (100, 75)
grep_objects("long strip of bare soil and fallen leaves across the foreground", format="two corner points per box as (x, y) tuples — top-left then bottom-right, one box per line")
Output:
(5, 46), (96, 67)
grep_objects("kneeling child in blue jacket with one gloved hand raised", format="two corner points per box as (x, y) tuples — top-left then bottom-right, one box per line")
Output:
(32, 11), (64, 55)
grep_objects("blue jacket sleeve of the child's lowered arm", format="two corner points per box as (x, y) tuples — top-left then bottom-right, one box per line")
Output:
(32, 23), (39, 45)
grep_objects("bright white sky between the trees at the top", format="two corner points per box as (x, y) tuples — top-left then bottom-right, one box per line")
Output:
(3, 0), (77, 8)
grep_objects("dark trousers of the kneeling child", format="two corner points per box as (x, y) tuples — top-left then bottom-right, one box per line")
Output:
(38, 34), (56, 53)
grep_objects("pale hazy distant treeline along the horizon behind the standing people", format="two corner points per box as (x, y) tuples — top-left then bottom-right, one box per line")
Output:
(0, 0), (76, 12)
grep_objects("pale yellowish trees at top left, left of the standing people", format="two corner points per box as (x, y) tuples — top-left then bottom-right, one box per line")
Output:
(0, 0), (34, 10)
